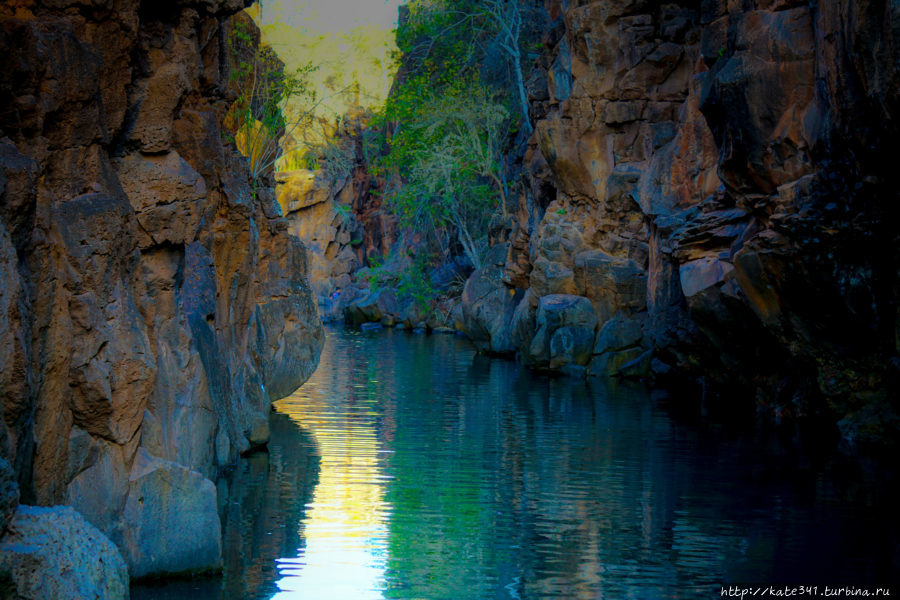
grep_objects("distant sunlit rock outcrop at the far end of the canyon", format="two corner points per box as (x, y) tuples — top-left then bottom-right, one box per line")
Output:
(276, 124), (472, 332)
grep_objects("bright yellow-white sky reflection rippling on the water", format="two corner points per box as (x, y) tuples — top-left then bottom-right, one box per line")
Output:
(273, 342), (390, 600)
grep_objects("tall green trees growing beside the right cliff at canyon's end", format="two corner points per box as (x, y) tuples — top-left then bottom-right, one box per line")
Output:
(363, 0), (541, 268)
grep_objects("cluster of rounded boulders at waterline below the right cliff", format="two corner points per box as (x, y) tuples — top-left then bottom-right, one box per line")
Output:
(456, 244), (652, 378)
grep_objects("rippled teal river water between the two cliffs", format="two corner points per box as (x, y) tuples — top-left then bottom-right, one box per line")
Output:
(132, 330), (900, 600)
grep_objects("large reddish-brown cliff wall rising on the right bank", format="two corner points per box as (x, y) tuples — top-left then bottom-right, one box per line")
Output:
(467, 0), (900, 448)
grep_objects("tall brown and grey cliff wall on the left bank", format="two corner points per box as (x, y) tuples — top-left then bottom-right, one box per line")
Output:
(0, 0), (323, 575)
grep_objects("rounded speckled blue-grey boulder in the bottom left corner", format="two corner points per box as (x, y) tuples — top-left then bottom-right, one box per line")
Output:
(0, 505), (128, 600)
